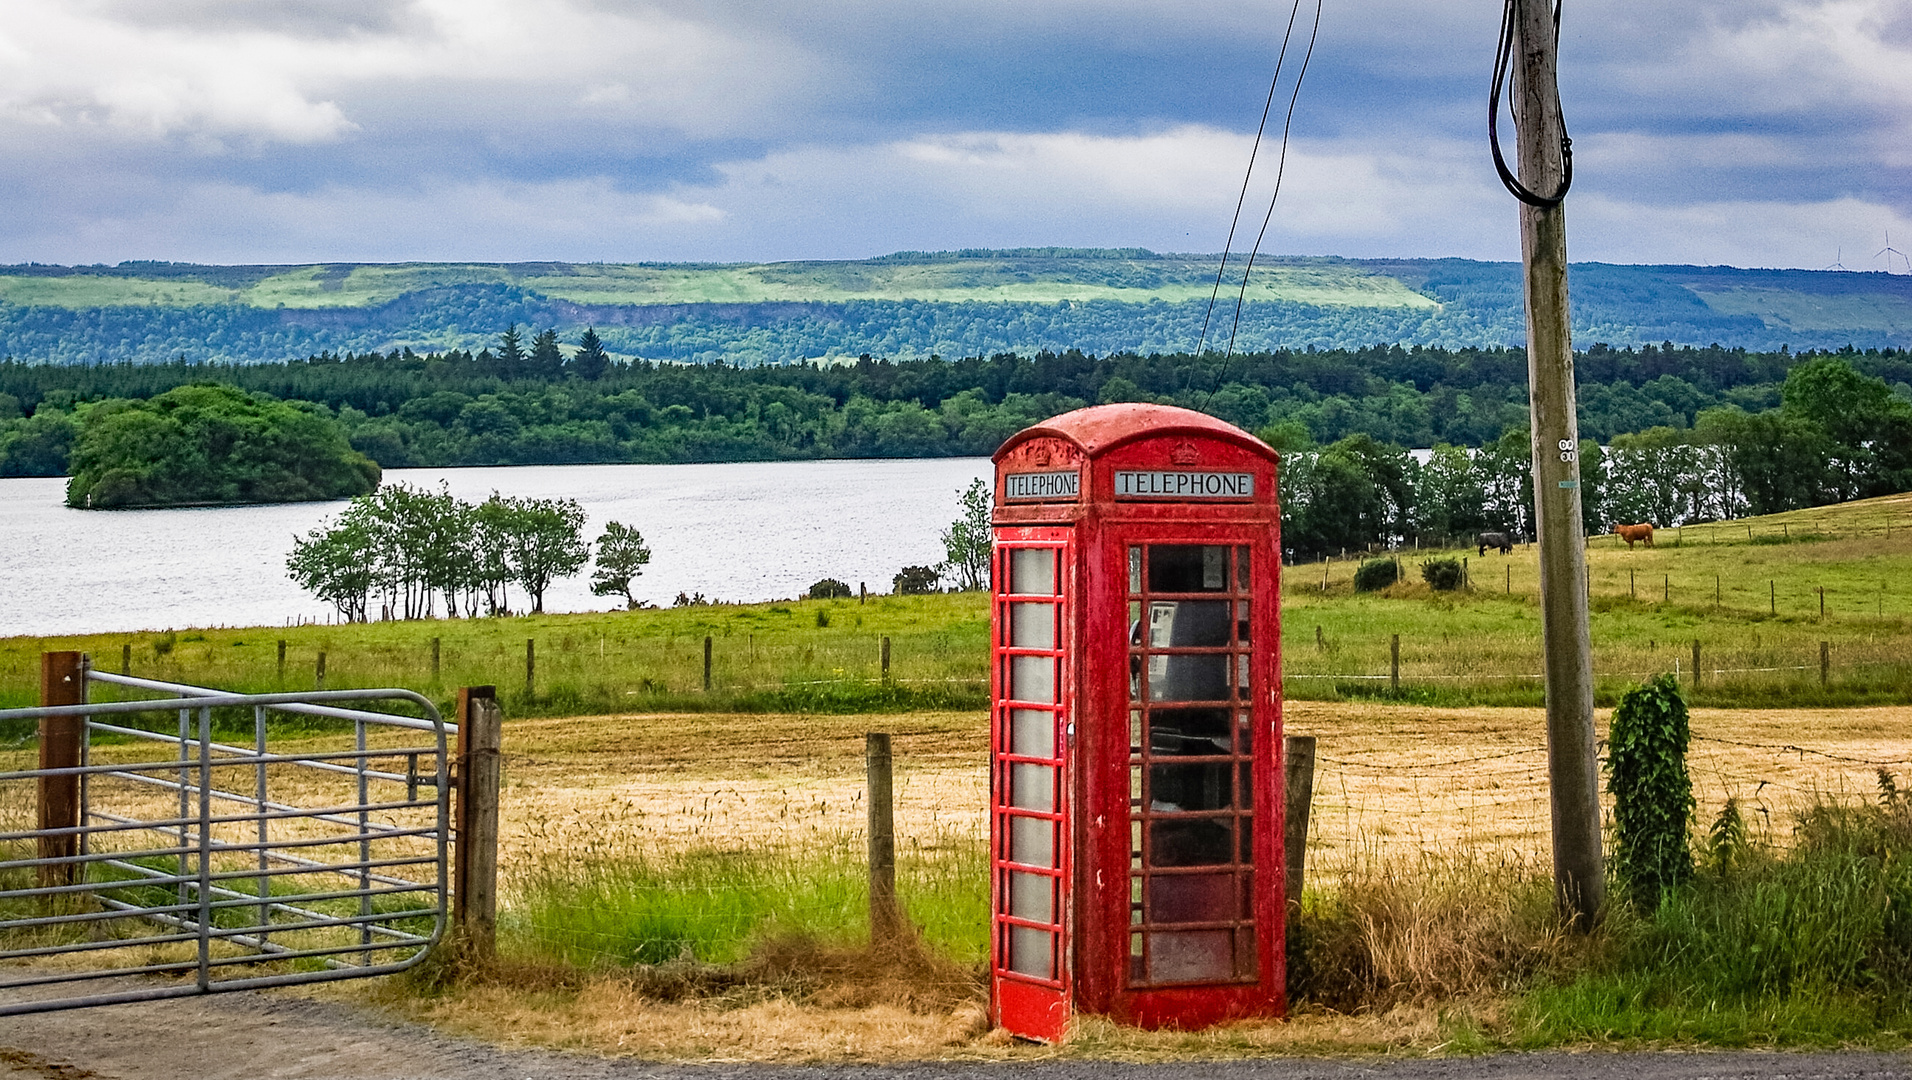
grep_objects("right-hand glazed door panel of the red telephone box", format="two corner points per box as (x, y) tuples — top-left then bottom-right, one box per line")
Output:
(1103, 526), (1281, 1026)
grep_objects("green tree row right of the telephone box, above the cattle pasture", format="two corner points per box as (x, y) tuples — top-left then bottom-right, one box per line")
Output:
(1264, 356), (1912, 558)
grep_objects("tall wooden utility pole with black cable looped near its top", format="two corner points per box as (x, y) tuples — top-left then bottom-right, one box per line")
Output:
(1510, 0), (1606, 929)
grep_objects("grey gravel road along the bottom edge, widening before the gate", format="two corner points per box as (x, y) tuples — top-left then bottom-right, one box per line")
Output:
(0, 992), (1912, 1080)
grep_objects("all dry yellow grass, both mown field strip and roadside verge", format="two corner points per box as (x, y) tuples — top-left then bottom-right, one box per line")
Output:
(347, 702), (1912, 1061)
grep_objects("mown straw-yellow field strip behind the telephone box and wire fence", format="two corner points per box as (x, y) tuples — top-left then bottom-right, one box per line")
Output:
(466, 702), (1912, 883)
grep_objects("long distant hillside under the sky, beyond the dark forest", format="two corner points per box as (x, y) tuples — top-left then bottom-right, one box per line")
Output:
(0, 248), (1912, 365)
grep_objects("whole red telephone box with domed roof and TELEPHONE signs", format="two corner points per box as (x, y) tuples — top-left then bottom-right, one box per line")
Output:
(990, 405), (1287, 1040)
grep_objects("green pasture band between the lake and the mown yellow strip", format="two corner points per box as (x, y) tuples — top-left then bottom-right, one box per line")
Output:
(11, 495), (1912, 717)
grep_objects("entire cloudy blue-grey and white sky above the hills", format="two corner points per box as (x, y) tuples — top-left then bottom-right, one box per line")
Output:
(0, 0), (1912, 271)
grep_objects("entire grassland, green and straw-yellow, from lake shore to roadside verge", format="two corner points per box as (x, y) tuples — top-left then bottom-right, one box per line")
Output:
(11, 497), (1912, 1061)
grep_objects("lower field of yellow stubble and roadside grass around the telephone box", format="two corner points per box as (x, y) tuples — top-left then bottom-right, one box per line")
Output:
(336, 702), (1912, 1061)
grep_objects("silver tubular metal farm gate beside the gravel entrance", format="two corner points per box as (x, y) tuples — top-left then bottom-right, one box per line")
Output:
(0, 654), (455, 1017)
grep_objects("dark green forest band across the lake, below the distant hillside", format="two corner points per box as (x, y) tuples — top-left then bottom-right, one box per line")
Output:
(0, 331), (1912, 476)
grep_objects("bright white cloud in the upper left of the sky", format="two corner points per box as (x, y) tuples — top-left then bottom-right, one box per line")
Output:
(0, 0), (818, 145)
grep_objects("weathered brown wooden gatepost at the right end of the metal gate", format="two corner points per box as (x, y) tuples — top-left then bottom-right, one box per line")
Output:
(451, 686), (505, 960)
